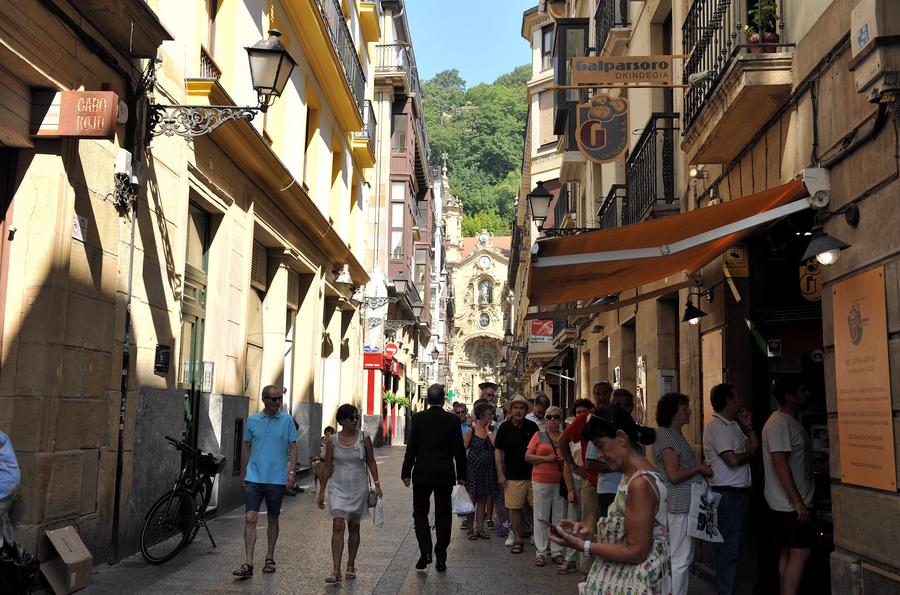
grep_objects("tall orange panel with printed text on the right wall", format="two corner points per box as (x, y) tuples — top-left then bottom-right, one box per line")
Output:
(832, 267), (897, 492)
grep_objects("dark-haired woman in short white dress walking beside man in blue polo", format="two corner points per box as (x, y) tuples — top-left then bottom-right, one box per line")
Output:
(319, 404), (382, 583)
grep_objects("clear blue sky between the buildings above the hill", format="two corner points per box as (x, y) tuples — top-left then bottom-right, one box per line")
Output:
(405, 0), (538, 87)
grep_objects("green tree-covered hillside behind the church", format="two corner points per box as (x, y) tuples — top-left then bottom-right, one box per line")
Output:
(422, 65), (531, 236)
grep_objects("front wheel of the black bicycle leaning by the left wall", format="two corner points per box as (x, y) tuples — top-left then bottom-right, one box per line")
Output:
(141, 491), (194, 564)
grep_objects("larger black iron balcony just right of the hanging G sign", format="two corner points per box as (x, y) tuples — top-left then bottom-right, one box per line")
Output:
(621, 112), (679, 225)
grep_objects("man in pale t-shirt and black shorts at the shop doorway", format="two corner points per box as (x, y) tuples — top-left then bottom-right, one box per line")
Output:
(762, 376), (816, 595)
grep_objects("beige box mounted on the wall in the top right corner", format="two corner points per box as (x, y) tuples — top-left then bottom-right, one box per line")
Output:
(850, 0), (900, 102)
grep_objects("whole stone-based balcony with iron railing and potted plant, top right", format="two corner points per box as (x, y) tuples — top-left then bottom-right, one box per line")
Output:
(681, 0), (793, 163)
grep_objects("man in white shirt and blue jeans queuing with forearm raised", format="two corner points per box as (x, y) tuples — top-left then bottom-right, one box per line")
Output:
(703, 384), (759, 595)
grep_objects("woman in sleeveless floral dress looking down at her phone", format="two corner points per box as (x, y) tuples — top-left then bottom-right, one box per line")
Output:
(547, 405), (672, 595)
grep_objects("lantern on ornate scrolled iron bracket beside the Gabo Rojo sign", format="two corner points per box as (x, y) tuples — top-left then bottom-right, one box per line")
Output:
(149, 29), (297, 140)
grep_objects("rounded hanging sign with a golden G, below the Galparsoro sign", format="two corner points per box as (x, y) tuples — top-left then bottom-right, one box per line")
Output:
(575, 93), (628, 163)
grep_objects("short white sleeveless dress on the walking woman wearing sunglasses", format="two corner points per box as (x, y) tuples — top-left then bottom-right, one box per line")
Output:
(328, 433), (369, 523)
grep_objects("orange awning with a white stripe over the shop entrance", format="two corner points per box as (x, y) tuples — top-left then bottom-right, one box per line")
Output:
(528, 180), (809, 315)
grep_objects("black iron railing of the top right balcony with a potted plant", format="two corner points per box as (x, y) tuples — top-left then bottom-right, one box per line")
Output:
(681, 0), (794, 129)
